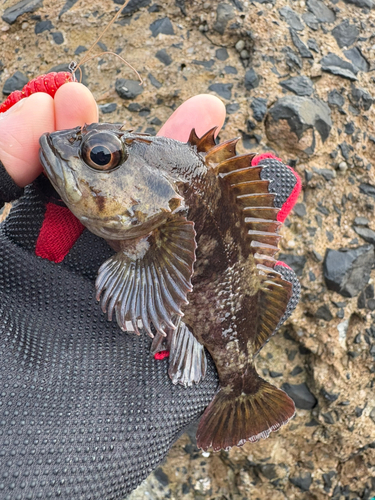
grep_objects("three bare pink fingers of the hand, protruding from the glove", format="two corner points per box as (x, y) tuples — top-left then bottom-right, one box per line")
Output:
(0, 82), (225, 187)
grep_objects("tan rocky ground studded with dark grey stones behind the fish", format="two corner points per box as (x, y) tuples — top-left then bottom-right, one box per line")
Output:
(0, 0), (375, 500)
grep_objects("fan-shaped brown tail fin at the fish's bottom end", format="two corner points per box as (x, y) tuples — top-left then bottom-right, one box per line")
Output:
(197, 370), (295, 451)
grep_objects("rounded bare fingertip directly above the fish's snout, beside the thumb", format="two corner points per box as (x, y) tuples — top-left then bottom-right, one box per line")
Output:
(54, 82), (99, 130)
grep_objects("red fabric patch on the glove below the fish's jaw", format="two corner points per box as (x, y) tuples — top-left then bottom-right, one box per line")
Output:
(35, 203), (85, 263)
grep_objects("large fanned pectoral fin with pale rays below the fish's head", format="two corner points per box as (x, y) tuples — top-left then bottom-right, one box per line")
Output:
(96, 216), (196, 337)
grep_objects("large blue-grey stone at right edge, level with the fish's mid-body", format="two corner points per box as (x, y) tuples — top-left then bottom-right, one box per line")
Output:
(323, 245), (375, 297)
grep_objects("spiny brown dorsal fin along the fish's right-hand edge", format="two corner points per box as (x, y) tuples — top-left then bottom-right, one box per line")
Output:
(193, 131), (298, 364)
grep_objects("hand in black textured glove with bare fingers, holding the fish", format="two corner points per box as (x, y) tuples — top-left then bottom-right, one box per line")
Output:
(0, 83), (302, 498)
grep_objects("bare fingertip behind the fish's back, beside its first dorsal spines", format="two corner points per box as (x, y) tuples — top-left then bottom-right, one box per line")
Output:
(158, 94), (226, 142)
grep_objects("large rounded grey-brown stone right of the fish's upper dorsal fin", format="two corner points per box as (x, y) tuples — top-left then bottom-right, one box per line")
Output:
(265, 96), (332, 155)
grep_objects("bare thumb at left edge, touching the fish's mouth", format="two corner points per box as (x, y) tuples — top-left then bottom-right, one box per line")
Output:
(0, 92), (55, 187)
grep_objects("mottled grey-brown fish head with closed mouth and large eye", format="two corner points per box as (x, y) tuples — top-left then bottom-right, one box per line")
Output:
(40, 123), (184, 240)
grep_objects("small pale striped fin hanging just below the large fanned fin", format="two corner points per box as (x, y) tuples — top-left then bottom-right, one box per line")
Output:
(168, 321), (207, 387)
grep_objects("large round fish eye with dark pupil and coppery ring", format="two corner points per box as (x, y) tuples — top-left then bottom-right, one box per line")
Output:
(81, 132), (128, 171)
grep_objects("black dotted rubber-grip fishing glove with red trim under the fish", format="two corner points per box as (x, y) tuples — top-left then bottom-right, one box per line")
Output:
(0, 84), (299, 500)
